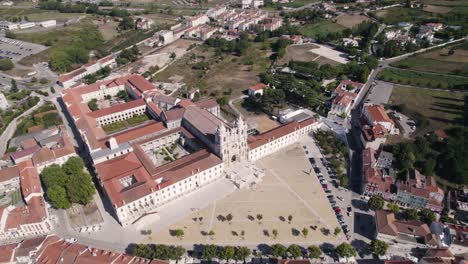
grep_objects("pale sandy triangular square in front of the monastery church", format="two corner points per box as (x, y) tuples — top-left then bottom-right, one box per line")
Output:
(148, 143), (344, 245)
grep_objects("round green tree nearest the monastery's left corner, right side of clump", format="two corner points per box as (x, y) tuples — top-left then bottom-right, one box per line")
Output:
(66, 172), (96, 204)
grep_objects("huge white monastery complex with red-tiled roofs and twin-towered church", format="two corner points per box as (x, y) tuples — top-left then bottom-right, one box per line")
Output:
(62, 75), (318, 226)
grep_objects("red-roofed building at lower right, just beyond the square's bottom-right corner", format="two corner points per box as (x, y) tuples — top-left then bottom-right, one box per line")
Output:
(375, 210), (438, 247)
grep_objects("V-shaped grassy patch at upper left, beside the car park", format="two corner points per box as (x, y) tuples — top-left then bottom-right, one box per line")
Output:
(16, 20), (97, 65)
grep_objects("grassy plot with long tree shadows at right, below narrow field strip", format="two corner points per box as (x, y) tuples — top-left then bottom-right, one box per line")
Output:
(389, 85), (464, 135)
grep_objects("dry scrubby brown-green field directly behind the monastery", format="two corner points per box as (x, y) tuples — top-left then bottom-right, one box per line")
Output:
(156, 43), (271, 100)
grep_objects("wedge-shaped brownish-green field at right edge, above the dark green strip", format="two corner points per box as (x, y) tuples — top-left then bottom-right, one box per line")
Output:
(392, 43), (468, 77)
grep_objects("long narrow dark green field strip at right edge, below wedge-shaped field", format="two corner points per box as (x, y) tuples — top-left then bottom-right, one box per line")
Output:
(378, 68), (468, 90)
